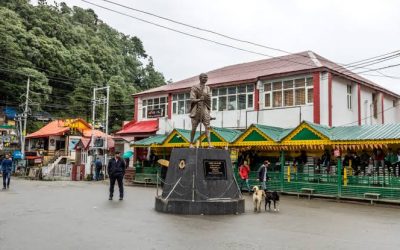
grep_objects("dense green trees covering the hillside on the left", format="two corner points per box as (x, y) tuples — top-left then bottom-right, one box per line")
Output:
(0, 0), (165, 132)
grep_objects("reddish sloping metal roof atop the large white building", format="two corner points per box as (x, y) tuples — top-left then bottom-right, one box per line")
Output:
(133, 51), (400, 98)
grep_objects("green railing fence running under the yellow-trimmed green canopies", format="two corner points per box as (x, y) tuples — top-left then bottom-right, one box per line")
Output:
(134, 166), (400, 202)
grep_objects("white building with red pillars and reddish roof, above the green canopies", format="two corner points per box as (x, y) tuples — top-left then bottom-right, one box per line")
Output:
(119, 51), (400, 140)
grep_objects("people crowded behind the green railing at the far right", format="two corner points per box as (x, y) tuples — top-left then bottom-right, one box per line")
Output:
(317, 148), (400, 176)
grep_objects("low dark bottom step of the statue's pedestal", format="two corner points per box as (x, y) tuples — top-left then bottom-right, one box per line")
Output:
(155, 197), (244, 215)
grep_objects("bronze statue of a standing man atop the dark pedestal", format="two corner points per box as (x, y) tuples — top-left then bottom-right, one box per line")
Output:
(189, 73), (211, 148)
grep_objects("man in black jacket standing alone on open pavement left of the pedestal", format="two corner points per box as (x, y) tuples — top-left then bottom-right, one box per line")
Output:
(107, 152), (126, 201)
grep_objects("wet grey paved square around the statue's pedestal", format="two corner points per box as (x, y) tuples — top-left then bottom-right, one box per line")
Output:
(0, 179), (400, 250)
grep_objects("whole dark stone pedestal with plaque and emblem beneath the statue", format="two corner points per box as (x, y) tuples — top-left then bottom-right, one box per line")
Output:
(155, 148), (244, 214)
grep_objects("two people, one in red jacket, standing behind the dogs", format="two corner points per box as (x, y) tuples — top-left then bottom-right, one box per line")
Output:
(239, 160), (270, 194)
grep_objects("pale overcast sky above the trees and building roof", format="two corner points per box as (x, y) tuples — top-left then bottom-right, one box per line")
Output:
(52, 0), (400, 94)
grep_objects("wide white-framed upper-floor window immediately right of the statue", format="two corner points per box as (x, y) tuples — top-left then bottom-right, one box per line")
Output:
(211, 84), (254, 111)
